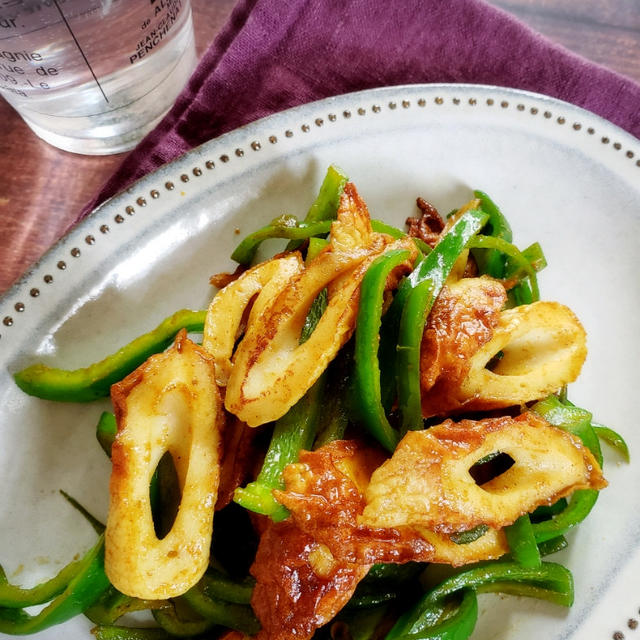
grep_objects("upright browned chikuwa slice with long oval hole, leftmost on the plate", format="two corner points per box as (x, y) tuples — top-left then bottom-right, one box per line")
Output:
(105, 332), (223, 599)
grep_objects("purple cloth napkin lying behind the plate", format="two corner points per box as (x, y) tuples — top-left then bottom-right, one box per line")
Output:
(81, 0), (640, 217)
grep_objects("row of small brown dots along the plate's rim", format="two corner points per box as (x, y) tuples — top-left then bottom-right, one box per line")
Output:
(0, 96), (640, 340)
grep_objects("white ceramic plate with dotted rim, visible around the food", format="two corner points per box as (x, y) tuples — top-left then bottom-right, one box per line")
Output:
(0, 85), (640, 640)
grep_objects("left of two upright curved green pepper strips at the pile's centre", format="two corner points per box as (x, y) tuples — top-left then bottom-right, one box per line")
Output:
(353, 249), (409, 452)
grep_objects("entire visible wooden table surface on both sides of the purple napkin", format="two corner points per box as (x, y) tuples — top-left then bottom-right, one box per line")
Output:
(0, 0), (640, 293)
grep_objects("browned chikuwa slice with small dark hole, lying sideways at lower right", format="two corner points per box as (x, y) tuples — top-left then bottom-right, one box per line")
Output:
(361, 412), (606, 534)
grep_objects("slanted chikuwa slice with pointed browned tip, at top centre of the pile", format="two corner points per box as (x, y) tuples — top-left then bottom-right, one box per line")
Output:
(225, 184), (416, 427)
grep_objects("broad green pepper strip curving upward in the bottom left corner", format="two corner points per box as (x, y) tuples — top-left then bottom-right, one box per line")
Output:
(0, 536), (109, 635)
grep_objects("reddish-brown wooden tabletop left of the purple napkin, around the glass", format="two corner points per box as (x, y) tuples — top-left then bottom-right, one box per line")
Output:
(0, 0), (235, 292)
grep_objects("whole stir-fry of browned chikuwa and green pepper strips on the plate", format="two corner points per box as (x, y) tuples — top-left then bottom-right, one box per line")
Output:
(0, 167), (627, 640)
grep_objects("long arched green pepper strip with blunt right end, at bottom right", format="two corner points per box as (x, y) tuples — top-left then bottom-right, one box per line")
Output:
(385, 560), (573, 640)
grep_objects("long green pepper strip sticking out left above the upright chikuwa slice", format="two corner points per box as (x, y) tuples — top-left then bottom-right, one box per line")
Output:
(14, 309), (207, 402)
